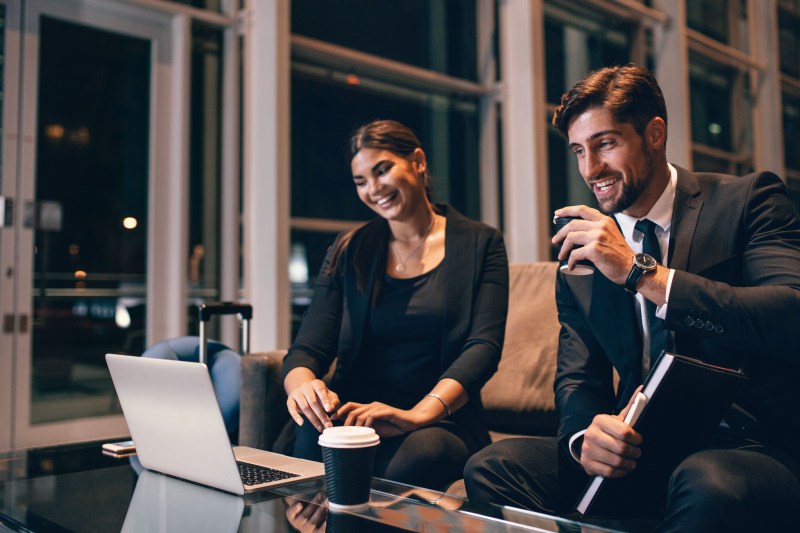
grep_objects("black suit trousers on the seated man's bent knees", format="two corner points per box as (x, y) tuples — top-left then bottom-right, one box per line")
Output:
(464, 437), (800, 533)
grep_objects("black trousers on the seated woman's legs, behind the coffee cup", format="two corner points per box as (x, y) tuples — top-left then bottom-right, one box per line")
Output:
(293, 420), (478, 490)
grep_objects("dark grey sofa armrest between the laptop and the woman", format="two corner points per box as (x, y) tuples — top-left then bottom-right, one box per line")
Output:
(239, 350), (289, 450)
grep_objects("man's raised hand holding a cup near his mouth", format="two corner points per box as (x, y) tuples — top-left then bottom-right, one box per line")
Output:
(552, 205), (634, 285)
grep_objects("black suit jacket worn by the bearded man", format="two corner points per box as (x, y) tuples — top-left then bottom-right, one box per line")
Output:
(555, 168), (800, 457)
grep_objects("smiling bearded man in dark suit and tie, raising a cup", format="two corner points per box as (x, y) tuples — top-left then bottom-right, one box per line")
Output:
(464, 66), (800, 532)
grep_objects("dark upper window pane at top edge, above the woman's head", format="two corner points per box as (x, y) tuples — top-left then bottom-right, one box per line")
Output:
(292, 0), (477, 80)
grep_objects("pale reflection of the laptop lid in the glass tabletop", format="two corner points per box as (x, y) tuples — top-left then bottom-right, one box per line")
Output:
(122, 470), (244, 533)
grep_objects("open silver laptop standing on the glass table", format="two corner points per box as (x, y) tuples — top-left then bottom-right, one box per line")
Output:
(106, 354), (325, 495)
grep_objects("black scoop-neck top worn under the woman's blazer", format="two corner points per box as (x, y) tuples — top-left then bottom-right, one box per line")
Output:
(342, 263), (444, 409)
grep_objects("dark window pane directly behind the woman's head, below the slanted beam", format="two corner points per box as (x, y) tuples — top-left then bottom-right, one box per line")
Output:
(292, 72), (480, 220)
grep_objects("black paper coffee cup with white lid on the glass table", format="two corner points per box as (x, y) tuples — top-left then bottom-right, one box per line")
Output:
(319, 426), (380, 511)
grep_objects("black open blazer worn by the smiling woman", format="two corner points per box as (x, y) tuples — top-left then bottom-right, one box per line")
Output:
(283, 206), (508, 445)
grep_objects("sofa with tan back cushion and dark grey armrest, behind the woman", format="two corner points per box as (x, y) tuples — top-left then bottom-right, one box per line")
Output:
(239, 262), (559, 452)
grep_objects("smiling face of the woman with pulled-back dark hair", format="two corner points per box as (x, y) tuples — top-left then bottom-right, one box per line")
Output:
(350, 148), (427, 221)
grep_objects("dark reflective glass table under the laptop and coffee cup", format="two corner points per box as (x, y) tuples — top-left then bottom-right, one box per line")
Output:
(0, 442), (632, 533)
